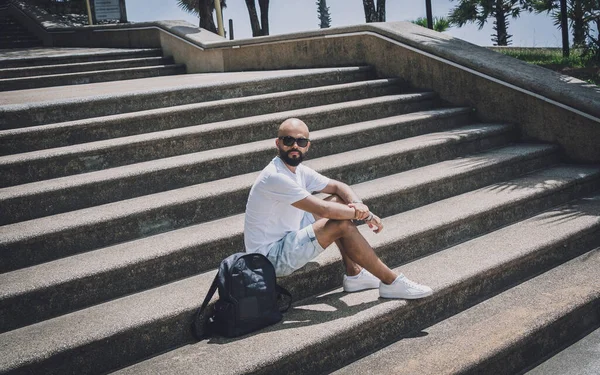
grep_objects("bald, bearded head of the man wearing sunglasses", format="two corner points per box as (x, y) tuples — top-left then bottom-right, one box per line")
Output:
(275, 118), (310, 167)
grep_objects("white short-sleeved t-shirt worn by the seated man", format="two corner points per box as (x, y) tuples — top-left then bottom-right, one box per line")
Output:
(244, 157), (329, 255)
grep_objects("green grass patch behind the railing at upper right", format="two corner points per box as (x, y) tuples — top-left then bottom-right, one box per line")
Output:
(494, 48), (600, 85)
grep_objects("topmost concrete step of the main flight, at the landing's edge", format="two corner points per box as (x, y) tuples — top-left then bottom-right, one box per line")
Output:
(0, 67), (375, 129)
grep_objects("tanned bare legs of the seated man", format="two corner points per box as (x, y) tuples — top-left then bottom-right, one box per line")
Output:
(313, 195), (398, 284)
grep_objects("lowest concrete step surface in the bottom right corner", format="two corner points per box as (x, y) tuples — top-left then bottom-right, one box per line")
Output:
(525, 326), (600, 375)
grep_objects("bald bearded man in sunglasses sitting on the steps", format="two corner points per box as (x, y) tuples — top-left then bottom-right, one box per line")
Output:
(244, 118), (432, 299)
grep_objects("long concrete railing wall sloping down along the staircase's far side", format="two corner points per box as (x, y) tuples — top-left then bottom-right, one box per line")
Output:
(5, 4), (600, 162)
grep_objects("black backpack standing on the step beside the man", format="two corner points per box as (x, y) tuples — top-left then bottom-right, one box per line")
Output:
(193, 253), (292, 340)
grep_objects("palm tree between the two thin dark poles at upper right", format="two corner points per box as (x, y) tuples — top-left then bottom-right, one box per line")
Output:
(449, 0), (527, 46)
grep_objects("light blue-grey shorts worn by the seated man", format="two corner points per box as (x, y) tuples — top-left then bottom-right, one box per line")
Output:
(267, 214), (324, 276)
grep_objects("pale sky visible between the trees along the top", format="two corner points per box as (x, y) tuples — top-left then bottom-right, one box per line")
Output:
(126, 0), (561, 47)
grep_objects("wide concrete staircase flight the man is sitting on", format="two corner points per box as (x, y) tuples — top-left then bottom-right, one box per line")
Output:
(0, 48), (600, 374)
